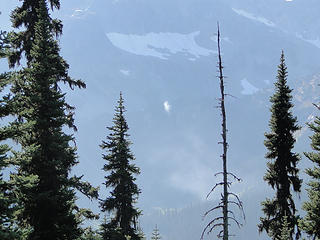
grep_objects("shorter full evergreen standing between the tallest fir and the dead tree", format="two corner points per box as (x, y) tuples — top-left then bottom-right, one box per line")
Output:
(101, 93), (140, 240)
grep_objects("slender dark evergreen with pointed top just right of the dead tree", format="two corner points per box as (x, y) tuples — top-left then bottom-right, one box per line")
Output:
(259, 52), (302, 239)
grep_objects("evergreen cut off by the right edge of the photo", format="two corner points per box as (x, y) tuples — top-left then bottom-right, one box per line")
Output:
(300, 117), (320, 240)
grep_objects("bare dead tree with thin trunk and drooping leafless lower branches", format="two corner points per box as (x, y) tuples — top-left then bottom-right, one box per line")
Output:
(201, 23), (245, 240)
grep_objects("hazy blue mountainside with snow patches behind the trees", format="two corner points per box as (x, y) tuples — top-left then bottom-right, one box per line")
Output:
(0, 0), (320, 240)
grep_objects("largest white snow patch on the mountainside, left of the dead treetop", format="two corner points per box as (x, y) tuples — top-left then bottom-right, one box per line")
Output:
(106, 31), (215, 60)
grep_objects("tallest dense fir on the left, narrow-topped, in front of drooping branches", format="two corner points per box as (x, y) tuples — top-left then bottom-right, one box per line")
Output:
(12, 1), (81, 240)
